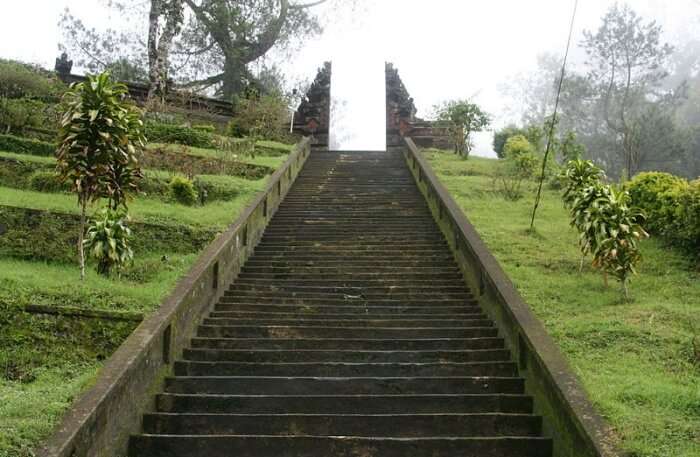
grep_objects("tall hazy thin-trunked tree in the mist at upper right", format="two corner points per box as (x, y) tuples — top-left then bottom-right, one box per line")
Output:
(582, 4), (673, 177)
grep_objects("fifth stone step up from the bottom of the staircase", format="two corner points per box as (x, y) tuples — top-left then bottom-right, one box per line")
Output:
(174, 360), (517, 378)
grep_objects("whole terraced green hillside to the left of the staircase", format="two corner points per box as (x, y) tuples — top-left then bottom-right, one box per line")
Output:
(0, 137), (291, 457)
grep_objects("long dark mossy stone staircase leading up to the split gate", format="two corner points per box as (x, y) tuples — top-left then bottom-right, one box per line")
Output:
(130, 148), (552, 457)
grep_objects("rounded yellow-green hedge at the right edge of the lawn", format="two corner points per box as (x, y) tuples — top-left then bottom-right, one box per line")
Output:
(627, 172), (700, 258)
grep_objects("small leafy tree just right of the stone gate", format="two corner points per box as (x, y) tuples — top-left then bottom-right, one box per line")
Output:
(436, 99), (491, 158)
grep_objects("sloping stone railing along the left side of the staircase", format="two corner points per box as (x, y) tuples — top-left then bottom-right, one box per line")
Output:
(37, 138), (311, 457)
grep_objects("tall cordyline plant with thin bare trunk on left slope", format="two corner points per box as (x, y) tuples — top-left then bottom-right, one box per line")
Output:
(56, 73), (146, 279)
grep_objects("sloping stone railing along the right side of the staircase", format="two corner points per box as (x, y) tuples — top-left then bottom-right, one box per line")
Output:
(404, 138), (619, 457)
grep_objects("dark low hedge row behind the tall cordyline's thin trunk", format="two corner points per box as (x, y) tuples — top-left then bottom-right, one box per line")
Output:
(0, 205), (217, 263)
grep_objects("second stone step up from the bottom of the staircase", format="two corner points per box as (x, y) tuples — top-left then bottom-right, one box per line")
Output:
(143, 413), (542, 438)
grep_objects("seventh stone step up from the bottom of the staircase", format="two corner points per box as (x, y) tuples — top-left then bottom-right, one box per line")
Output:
(192, 337), (505, 351)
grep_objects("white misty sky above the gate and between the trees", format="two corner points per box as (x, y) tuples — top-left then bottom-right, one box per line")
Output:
(0, 0), (700, 154)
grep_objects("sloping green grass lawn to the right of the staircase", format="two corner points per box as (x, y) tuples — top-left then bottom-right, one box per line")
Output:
(425, 150), (700, 457)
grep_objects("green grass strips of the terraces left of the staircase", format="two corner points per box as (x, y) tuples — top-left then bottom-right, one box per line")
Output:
(0, 140), (291, 457)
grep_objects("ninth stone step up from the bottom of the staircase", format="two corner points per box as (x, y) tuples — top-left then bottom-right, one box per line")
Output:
(202, 316), (494, 328)
